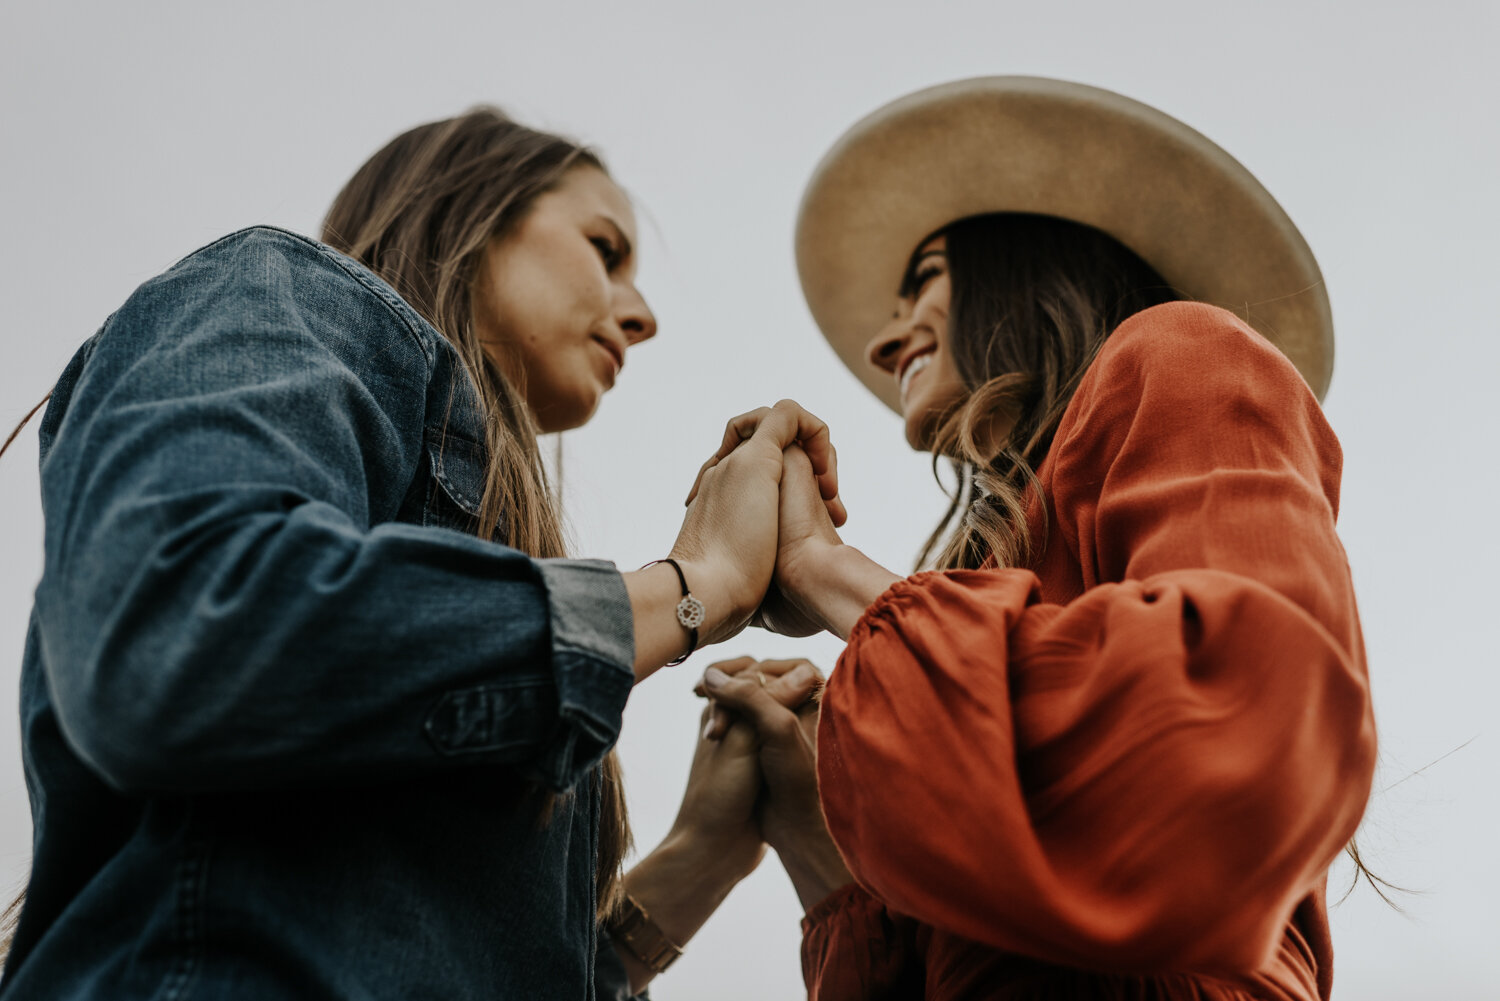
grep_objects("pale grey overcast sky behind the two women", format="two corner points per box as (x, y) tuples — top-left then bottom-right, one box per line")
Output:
(0, 0), (1500, 1001)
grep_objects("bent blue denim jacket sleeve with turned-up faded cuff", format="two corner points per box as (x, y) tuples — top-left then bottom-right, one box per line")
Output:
(36, 228), (633, 792)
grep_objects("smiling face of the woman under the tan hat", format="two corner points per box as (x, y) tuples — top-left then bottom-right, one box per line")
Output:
(866, 234), (968, 449)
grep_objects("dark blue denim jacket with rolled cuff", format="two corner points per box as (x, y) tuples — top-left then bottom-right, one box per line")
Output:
(0, 228), (635, 1001)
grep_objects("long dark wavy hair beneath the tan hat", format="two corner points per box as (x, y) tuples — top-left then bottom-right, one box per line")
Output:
(902, 213), (1409, 911)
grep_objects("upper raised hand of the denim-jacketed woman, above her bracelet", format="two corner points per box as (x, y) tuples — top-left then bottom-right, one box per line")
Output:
(672, 399), (843, 645)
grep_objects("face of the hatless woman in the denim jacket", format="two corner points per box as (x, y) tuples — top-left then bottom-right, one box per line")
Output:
(473, 167), (656, 431)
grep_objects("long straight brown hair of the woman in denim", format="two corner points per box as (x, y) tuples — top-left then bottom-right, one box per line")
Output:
(321, 107), (630, 917)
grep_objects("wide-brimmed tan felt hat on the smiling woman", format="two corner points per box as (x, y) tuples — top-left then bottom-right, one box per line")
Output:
(797, 77), (1334, 411)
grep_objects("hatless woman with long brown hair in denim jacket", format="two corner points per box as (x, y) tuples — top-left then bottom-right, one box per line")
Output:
(0, 110), (842, 1001)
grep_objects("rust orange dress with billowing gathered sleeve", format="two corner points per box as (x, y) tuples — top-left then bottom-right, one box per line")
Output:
(803, 303), (1376, 1001)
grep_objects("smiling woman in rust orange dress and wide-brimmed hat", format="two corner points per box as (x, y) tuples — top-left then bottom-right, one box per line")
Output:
(705, 78), (1376, 1001)
